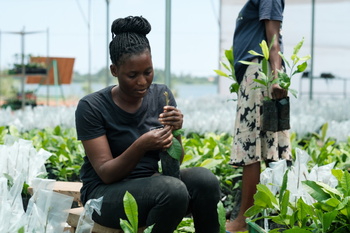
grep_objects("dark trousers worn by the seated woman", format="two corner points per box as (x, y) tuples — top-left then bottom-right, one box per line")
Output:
(88, 167), (220, 233)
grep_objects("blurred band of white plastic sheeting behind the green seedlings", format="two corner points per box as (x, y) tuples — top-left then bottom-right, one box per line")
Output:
(0, 95), (350, 141)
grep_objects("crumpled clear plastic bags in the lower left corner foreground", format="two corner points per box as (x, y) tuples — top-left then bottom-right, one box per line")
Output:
(0, 136), (73, 233)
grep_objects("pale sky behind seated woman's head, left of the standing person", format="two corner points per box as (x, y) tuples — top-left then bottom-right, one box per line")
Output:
(0, 0), (219, 76)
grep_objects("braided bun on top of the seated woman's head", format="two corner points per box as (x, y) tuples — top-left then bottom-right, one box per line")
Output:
(111, 16), (151, 36)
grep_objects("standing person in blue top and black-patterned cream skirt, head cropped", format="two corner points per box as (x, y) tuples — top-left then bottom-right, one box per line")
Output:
(226, 0), (291, 232)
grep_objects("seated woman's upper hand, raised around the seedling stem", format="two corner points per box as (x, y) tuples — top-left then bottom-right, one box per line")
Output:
(158, 106), (183, 130)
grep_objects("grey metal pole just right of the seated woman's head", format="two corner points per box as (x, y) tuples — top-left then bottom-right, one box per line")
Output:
(165, 0), (171, 88)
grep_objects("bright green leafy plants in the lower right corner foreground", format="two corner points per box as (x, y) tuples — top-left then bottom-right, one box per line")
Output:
(245, 169), (350, 233)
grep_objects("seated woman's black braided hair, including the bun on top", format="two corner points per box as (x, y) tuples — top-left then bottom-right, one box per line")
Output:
(109, 16), (151, 66)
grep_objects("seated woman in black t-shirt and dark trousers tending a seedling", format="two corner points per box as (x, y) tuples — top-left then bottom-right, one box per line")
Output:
(76, 16), (220, 233)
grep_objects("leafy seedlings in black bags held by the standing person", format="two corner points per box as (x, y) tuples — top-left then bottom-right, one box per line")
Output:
(240, 37), (311, 132)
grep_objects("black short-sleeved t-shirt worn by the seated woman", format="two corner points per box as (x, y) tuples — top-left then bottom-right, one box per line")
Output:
(75, 84), (176, 202)
